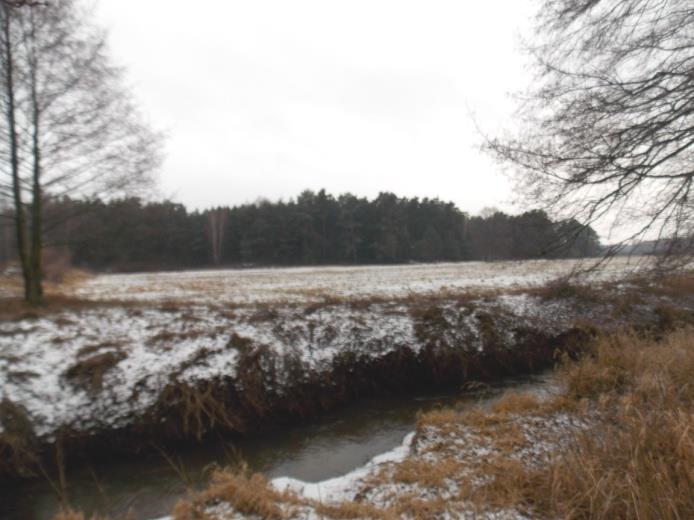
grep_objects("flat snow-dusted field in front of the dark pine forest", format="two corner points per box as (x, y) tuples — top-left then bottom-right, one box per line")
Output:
(68, 258), (643, 304)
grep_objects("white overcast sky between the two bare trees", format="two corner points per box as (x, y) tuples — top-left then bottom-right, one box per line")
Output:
(92, 0), (533, 213)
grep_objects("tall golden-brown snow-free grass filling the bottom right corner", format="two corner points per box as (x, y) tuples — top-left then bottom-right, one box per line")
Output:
(526, 329), (694, 519)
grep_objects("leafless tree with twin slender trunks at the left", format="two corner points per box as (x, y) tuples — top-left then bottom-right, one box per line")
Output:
(0, 0), (160, 303)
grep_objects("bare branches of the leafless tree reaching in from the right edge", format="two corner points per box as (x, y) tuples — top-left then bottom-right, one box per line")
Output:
(487, 0), (694, 266)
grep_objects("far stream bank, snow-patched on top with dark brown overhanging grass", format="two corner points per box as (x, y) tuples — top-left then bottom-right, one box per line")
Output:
(0, 284), (690, 479)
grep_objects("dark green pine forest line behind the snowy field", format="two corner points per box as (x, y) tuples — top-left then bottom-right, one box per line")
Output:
(16, 190), (600, 271)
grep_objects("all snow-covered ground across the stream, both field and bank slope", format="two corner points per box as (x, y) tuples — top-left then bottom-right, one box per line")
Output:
(0, 259), (664, 439)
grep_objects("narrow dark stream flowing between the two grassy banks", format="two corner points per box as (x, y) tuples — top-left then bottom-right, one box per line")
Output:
(0, 375), (550, 520)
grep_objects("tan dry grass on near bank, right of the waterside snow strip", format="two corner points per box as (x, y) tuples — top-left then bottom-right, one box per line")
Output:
(392, 329), (694, 519)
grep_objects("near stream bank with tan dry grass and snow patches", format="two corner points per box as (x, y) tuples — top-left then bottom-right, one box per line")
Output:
(173, 323), (694, 520)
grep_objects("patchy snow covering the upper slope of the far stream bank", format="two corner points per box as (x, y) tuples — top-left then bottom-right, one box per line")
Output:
(0, 294), (571, 438)
